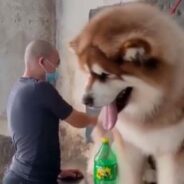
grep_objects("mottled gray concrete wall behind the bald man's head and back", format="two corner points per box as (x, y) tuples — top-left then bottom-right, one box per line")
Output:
(0, 0), (55, 135)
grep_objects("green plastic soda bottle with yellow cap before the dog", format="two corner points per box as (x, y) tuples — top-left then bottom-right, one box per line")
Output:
(94, 138), (118, 184)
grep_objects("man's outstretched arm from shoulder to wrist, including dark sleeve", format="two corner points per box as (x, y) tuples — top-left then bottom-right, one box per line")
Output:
(36, 82), (97, 128)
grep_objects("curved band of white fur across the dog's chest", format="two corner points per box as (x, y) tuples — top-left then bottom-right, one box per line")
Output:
(116, 120), (184, 154)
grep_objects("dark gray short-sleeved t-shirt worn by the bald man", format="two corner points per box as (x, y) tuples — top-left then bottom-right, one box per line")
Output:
(7, 78), (73, 181)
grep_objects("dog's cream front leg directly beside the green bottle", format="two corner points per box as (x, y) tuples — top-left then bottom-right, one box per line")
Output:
(114, 134), (145, 184)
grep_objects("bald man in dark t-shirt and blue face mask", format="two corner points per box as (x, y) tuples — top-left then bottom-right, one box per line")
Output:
(3, 40), (97, 184)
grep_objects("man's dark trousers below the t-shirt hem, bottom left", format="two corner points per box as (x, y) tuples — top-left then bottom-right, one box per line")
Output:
(3, 171), (57, 184)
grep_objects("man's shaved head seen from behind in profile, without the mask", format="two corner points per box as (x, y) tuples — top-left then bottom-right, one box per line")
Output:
(24, 40), (60, 79)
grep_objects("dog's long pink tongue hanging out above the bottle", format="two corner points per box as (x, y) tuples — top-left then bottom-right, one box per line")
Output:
(100, 103), (118, 130)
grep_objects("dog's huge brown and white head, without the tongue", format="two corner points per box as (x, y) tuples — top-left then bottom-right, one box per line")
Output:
(71, 3), (183, 121)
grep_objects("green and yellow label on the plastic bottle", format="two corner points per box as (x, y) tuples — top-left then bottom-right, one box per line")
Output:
(94, 164), (118, 181)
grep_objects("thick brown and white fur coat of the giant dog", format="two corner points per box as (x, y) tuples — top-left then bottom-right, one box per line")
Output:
(71, 3), (184, 184)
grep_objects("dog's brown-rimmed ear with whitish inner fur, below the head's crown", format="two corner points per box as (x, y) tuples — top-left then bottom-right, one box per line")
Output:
(121, 38), (158, 69)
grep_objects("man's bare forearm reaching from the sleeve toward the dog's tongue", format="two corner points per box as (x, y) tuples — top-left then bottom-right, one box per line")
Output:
(65, 109), (97, 128)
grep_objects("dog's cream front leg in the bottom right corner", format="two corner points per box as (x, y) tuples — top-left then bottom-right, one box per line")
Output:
(156, 153), (184, 184)
